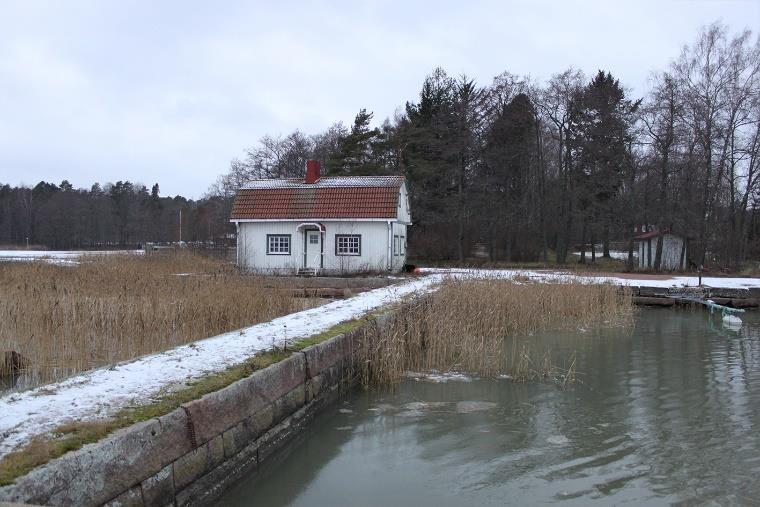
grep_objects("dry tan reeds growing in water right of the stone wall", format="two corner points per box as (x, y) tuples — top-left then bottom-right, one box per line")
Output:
(360, 279), (634, 387)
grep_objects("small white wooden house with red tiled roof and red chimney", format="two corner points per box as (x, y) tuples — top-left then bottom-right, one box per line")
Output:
(230, 160), (412, 274)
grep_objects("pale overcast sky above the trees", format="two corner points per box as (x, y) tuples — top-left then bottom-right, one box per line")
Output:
(0, 0), (760, 198)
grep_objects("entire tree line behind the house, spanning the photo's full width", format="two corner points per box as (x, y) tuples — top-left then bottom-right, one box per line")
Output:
(0, 23), (760, 269)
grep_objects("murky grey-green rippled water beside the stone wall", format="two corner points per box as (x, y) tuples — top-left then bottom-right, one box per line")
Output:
(214, 309), (760, 507)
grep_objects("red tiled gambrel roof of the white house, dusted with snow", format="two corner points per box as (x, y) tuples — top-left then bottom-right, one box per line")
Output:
(230, 176), (404, 220)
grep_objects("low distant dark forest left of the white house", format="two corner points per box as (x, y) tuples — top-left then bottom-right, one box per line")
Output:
(0, 180), (229, 249)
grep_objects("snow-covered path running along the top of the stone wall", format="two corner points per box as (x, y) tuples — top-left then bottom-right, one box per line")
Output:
(0, 275), (443, 457)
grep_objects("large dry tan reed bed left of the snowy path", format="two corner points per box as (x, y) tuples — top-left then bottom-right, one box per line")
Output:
(0, 253), (317, 387)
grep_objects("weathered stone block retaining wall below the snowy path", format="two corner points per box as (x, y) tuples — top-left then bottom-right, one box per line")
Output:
(0, 315), (389, 507)
